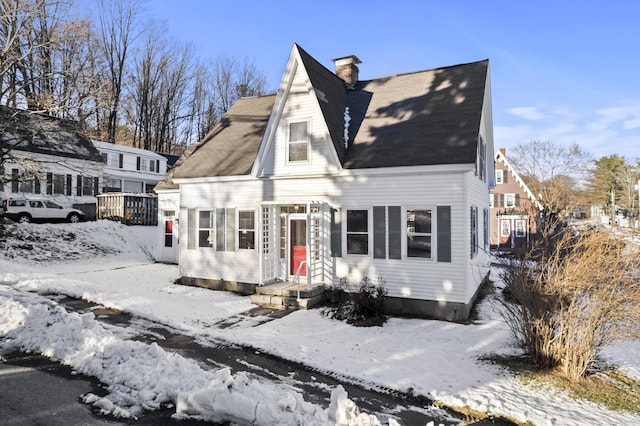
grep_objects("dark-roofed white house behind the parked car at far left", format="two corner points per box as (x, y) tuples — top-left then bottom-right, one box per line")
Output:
(0, 106), (104, 218)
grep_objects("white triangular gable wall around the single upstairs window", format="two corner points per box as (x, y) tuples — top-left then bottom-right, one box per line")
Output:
(263, 57), (338, 176)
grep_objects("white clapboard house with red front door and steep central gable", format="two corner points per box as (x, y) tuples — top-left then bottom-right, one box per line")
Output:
(156, 45), (495, 319)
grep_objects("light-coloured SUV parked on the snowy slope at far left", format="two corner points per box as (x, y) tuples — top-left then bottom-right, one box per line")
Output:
(2, 198), (84, 223)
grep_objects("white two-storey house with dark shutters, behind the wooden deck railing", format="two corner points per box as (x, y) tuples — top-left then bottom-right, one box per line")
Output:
(93, 141), (167, 193)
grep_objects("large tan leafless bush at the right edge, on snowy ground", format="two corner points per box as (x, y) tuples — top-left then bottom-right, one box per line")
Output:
(500, 226), (640, 379)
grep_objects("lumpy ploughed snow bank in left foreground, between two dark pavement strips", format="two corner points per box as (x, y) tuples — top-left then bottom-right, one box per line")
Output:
(0, 287), (380, 425)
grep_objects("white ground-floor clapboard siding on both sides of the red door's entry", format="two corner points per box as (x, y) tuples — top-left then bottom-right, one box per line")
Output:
(175, 163), (488, 303)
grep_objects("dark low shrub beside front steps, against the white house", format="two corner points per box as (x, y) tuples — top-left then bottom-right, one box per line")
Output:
(323, 277), (387, 326)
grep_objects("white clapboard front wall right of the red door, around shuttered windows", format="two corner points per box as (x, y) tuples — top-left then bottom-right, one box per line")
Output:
(332, 170), (467, 303)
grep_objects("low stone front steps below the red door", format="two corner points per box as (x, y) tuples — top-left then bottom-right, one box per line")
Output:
(251, 282), (324, 310)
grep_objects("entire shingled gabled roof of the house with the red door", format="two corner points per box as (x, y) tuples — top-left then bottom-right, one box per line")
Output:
(166, 44), (489, 178)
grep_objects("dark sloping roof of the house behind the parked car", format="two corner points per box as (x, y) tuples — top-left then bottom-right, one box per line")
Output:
(0, 105), (102, 162)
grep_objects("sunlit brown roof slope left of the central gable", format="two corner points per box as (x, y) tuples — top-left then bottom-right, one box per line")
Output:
(172, 95), (276, 179)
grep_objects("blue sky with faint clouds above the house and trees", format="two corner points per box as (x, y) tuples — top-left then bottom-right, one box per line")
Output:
(145, 0), (640, 161)
